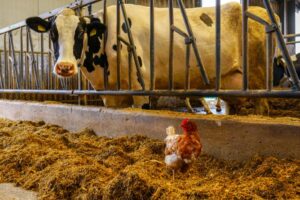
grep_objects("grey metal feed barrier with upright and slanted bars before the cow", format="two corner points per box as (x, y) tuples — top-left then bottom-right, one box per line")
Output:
(0, 0), (300, 106)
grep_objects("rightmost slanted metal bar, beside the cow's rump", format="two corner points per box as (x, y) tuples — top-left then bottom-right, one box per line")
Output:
(264, 0), (300, 90)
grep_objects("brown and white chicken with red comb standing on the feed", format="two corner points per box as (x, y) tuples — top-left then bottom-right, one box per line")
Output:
(165, 119), (202, 179)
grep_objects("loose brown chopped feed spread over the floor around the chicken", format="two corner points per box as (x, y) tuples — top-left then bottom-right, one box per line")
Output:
(0, 120), (300, 200)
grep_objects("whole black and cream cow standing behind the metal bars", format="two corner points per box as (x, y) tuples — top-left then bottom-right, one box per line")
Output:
(26, 3), (275, 112)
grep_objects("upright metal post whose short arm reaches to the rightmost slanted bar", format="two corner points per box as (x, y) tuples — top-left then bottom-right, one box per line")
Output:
(242, 0), (249, 91)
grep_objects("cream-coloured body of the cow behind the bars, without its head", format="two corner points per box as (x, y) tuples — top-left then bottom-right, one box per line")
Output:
(83, 3), (274, 111)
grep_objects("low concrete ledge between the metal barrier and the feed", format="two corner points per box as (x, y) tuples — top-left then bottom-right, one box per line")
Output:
(0, 100), (300, 161)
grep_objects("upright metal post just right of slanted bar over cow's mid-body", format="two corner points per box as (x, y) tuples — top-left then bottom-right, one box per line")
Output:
(216, 0), (221, 91)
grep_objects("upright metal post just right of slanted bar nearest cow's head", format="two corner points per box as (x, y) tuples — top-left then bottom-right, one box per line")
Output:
(150, 0), (155, 90)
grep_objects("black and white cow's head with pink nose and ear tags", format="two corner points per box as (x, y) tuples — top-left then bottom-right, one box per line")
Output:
(26, 9), (106, 77)
